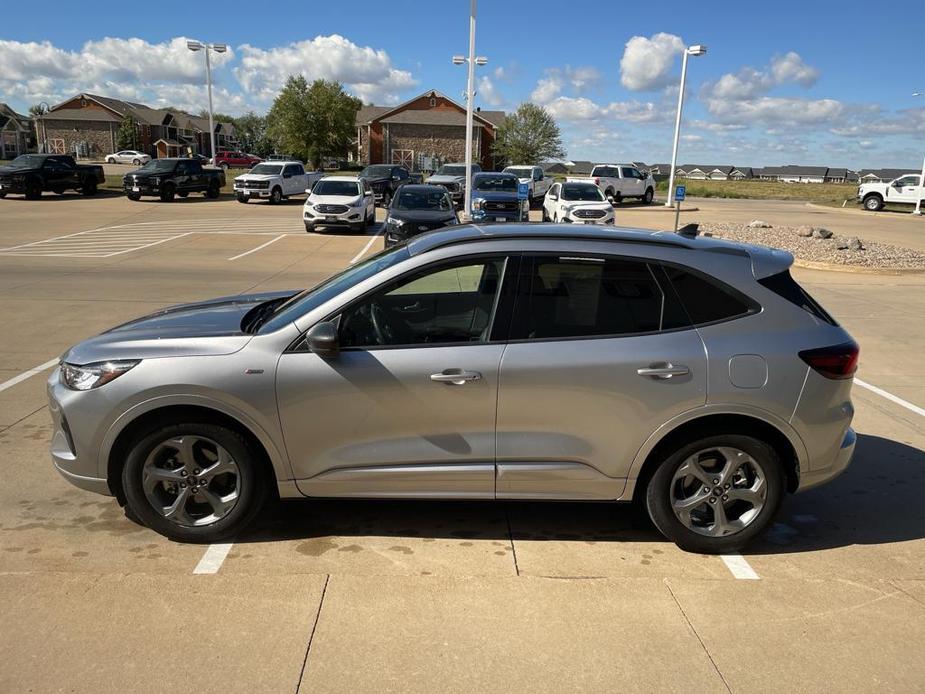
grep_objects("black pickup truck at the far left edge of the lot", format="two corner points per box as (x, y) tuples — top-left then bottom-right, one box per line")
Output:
(0, 154), (106, 200)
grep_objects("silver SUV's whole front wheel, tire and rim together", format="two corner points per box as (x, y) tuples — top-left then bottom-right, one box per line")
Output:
(122, 423), (267, 542)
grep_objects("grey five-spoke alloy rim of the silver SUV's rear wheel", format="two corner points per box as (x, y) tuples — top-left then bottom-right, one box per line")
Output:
(669, 446), (768, 537)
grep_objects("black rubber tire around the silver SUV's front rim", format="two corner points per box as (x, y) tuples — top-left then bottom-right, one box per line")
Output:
(122, 423), (268, 543)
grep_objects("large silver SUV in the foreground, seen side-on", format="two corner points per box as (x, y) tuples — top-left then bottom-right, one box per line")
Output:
(48, 224), (858, 552)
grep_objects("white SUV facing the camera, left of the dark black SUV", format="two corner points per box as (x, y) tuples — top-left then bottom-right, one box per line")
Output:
(302, 176), (376, 233)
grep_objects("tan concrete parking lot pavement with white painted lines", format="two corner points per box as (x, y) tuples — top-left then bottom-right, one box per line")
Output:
(0, 195), (925, 693)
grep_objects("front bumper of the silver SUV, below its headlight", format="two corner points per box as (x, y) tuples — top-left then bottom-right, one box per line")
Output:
(48, 368), (113, 496)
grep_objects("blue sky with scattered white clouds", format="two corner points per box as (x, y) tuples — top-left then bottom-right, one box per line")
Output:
(0, 0), (925, 167)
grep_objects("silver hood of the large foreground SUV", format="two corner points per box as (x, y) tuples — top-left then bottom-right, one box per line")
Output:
(61, 291), (296, 364)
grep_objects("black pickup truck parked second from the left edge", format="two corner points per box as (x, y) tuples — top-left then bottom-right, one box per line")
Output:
(122, 158), (225, 202)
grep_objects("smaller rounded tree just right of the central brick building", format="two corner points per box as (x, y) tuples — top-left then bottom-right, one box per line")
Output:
(494, 103), (565, 164)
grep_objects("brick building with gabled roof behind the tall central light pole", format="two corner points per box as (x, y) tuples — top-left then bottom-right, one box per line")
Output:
(356, 90), (505, 171)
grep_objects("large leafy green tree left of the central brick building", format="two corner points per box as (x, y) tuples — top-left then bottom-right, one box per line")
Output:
(267, 75), (362, 168)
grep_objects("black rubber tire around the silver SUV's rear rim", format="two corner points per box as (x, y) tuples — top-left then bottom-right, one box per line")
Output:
(645, 434), (786, 554)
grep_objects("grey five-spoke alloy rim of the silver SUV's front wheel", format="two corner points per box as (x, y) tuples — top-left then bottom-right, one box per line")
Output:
(142, 434), (241, 527)
